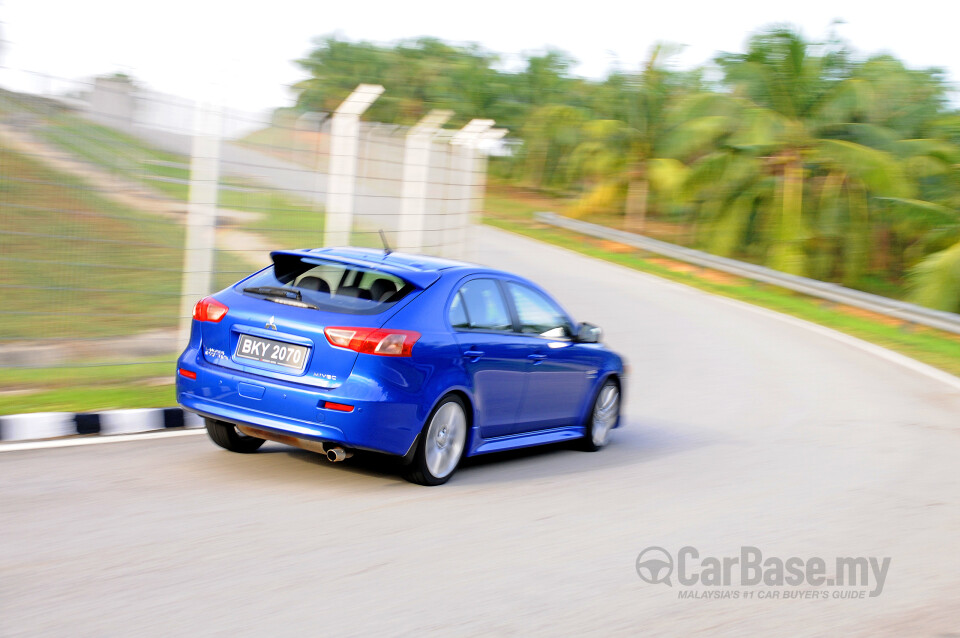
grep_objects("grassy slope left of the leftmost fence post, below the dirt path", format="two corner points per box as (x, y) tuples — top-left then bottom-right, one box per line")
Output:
(0, 146), (183, 340)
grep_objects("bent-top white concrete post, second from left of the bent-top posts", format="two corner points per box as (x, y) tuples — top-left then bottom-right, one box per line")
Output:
(397, 109), (453, 252)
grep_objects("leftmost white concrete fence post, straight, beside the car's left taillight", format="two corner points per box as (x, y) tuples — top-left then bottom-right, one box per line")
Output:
(179, 103), (222, 344)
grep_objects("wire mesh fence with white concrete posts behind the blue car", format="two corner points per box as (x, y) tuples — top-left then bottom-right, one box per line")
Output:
(0, 69), (500, 389)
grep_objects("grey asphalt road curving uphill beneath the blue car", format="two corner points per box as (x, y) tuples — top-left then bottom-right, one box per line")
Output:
(0, 228), (960, 636)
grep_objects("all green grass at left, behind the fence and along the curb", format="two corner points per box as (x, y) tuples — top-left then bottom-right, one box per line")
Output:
(0, 90), (338, 414)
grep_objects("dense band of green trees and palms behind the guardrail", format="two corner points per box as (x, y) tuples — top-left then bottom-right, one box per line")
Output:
(294, 27), (960, 312)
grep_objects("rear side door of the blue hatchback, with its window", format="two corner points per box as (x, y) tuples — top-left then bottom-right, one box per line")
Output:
(448, 277), (530, 439)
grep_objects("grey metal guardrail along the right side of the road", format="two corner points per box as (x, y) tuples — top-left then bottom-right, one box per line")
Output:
(534, 213), (960, 334)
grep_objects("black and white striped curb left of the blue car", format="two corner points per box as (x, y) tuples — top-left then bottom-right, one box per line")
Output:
(0, 408), (203, 441)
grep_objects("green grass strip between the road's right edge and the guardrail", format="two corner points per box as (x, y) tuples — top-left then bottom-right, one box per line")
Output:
(484, 183), (960, 376)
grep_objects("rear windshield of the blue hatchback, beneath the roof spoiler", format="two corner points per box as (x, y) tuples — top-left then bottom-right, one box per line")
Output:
(238, 255), (417, 315)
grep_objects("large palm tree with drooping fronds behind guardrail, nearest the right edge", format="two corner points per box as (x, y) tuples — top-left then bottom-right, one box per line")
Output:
(692, 28), (913, 283)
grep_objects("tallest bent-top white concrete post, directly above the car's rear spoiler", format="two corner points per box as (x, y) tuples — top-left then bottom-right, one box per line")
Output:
(323, 84), (383, 246)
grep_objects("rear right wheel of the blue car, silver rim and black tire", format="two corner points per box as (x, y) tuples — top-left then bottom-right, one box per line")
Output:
(404, 394), (469, 485)
